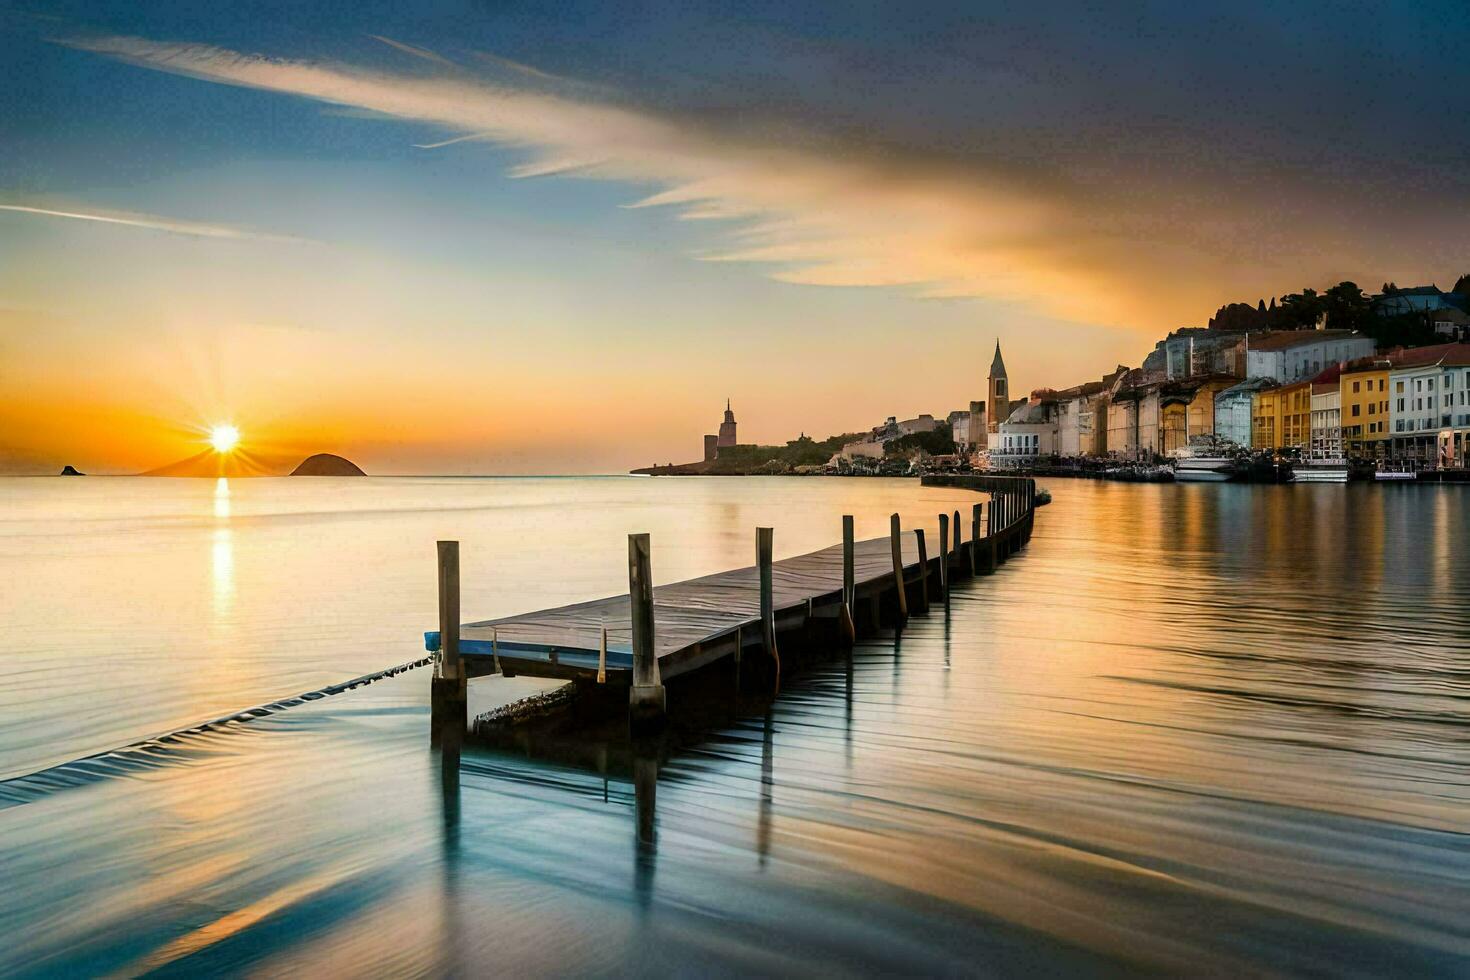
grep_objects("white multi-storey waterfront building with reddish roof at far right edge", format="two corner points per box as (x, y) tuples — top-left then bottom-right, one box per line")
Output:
(1388, 344), (1470, 466)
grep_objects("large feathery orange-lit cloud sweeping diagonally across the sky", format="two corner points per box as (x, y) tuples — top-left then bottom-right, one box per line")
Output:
(54, 37), (1434, 328)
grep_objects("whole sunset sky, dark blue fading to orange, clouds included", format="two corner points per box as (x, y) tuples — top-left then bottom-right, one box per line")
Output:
(0, 3), (1470, 472)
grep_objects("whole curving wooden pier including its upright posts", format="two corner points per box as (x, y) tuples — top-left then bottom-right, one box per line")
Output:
(425, 475), (1036, 724)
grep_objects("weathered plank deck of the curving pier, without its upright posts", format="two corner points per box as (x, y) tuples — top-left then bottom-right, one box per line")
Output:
(425, 476), (1035, 696)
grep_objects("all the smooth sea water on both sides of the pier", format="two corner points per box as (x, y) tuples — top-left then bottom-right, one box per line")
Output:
(0, 478), (1470, 976)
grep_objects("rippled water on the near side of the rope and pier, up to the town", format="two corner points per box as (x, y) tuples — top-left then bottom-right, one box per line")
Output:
(0, 482), (1470, 974)
